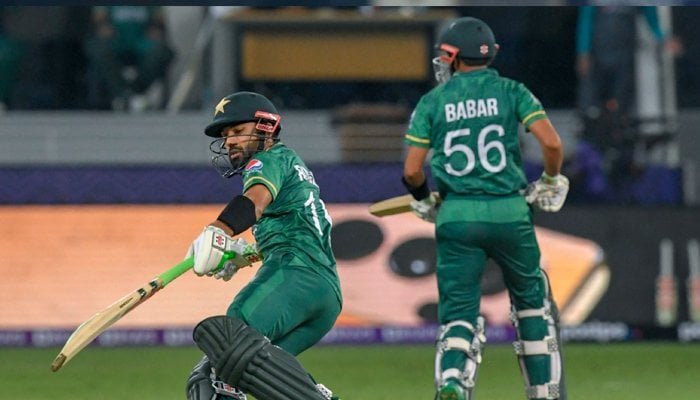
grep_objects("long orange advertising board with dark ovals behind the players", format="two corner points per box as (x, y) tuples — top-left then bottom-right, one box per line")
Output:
(0, 204), (700, 346)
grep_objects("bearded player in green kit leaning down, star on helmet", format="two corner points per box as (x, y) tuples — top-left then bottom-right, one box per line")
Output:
(187, 92), (342, 400)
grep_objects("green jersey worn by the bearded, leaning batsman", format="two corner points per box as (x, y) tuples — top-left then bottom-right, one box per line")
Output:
(242, 143), (340, 297)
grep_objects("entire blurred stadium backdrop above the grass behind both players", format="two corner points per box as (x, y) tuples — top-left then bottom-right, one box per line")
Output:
(0, 1), (700, 354)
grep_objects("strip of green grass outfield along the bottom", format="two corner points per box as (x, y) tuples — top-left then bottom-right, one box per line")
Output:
(0, 343), (700, 400)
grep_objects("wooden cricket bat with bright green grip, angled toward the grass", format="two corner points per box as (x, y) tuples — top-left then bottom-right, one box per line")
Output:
(51, 258), (193, 372)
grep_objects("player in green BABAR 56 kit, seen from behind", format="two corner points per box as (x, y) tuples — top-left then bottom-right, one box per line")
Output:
(403, 17), (569, 400)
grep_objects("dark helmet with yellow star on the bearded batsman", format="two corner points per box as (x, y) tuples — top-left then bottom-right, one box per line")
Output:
(204, 92), (280, 138)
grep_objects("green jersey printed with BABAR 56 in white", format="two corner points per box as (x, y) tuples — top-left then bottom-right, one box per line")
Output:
(405, 68), (546, 196)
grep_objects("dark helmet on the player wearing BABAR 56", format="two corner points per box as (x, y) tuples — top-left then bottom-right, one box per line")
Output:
(437, 17), (498, 62)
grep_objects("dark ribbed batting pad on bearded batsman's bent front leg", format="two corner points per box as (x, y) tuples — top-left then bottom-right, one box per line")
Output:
(193, 316), (325, 400)
